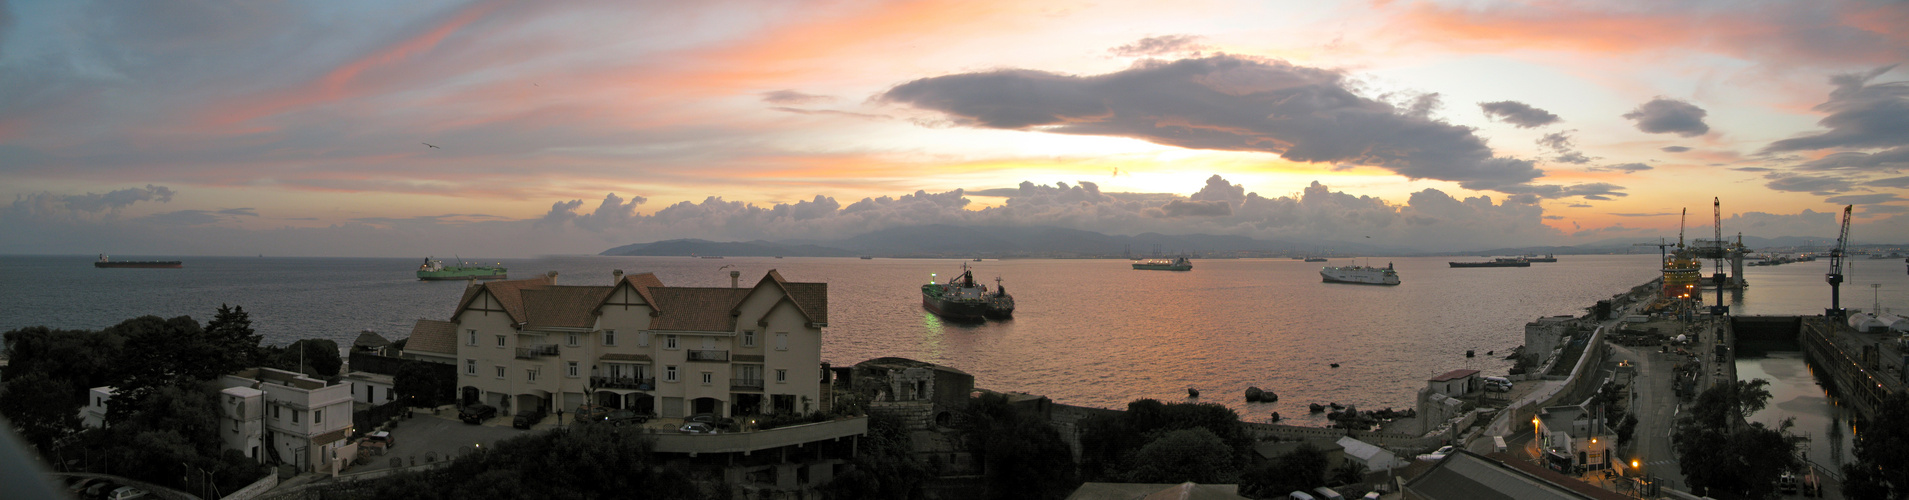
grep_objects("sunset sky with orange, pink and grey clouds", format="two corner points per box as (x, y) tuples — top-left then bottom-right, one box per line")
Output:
(0, 0), (1909, 258)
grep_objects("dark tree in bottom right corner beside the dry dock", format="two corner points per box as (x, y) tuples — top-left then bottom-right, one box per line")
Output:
(1842, 393), (1909, 500)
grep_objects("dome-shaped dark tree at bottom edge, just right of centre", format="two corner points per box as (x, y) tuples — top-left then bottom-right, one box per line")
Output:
(1126, 427), (1239, 485)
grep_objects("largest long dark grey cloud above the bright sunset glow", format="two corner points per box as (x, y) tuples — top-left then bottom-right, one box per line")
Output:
(878, 55), (1544, 189)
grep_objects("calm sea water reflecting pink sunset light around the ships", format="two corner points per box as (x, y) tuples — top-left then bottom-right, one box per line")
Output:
(0, 254), (1901, 424)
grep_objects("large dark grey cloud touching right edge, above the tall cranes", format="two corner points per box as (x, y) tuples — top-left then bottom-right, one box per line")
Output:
(1764, 65), (1909, 153)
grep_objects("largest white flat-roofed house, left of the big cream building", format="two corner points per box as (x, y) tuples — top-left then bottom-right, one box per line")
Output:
(220, 368), (351, 471)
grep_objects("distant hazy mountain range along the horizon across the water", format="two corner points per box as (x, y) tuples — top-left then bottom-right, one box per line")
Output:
(601, 223), (1893, 258)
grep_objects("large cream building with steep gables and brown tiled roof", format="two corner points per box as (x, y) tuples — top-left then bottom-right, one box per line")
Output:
(439, 271), (829, 418)
